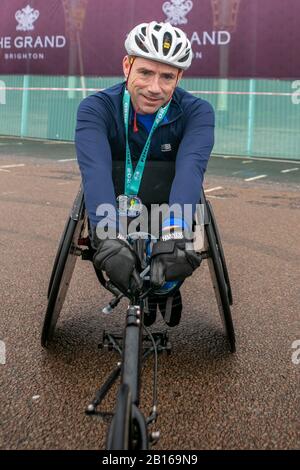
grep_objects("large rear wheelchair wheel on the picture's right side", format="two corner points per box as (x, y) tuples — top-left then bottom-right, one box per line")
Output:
(205, 206), (235, 352)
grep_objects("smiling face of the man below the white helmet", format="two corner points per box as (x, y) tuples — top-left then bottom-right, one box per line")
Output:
(123, 56), (182, 114)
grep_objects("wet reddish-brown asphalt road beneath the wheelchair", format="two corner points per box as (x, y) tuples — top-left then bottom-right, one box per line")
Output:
(0, 139), (300, 450)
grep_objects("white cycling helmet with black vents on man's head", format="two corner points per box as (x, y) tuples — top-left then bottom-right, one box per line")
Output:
(125, 21), (193, 70)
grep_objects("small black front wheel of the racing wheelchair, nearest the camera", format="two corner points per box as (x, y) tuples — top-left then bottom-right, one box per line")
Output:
(106, 383), (148, 450)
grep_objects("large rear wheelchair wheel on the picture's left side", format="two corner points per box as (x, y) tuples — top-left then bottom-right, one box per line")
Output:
(41, 191), (84, 347)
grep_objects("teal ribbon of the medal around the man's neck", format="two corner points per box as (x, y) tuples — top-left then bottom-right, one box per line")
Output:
(123, 89), (170, 196)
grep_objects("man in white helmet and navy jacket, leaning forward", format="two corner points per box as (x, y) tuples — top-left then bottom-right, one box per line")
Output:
(75, 21), (214, 326)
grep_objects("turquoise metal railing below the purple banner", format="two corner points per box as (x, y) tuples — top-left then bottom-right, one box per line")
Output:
(0, 75), (300, 160)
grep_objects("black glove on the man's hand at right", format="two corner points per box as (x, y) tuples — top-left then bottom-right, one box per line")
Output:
(150, 231), (202, 287)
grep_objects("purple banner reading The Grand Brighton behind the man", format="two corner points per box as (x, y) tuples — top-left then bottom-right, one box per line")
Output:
(0, 0), (300, 79)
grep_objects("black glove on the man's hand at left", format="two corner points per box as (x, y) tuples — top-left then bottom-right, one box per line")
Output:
(92, 232), (143, 294)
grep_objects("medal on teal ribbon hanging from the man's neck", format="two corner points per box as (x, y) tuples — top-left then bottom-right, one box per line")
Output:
(117, 89), (170, 217)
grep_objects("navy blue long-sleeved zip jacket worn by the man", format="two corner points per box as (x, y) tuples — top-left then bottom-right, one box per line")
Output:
(75, 83), (214, 226)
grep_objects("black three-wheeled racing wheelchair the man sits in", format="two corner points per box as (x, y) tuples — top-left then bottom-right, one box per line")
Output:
(41, 162), (235, 450)
